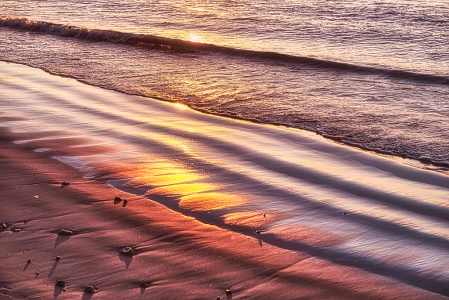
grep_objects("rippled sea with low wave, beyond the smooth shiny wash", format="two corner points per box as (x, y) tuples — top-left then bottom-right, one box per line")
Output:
(0, 0), (449, 167)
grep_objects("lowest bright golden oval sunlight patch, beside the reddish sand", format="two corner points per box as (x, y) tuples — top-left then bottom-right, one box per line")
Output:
(179, 193), (245, 211)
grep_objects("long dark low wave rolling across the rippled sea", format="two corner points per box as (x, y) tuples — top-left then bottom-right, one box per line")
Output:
(0, 17), (449, 85)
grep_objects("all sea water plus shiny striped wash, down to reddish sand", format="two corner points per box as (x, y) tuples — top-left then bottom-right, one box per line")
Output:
(0, 0), (449, 296)
